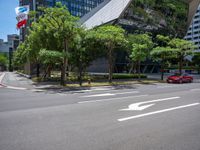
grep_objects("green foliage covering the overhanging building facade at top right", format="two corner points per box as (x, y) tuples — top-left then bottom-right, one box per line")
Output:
(132, 0), (188, 37)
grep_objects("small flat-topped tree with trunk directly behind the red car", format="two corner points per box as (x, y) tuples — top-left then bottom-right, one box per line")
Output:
(169, 38), (195, 74)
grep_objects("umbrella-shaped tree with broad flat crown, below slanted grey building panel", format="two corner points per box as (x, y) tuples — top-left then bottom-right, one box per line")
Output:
(96, 25), (126, 83)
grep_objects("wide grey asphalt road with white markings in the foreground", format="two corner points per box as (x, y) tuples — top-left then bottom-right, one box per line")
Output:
(0, 72), (200, 150)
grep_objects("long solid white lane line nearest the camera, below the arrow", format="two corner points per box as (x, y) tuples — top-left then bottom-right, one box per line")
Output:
(118, 103), (200, 122)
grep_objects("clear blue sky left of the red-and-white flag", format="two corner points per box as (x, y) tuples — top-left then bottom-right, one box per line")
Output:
(0, 0), (19, 41)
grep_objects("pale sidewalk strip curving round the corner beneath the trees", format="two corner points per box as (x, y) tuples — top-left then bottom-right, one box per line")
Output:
(1, 72), (153, 91)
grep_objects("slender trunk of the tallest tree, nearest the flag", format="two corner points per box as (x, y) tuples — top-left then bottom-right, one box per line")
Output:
(60, 40), (68, 86)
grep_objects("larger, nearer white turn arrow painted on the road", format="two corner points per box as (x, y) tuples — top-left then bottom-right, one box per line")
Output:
(119, 97), (180, 111)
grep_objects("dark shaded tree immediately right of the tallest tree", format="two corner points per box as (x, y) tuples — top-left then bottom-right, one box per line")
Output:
(70, 28), (102, 86)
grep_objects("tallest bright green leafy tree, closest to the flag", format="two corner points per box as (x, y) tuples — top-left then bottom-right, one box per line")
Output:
(13, 3), (80, 85)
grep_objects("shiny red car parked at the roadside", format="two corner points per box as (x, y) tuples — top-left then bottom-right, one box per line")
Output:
(167, 74), (193, 83)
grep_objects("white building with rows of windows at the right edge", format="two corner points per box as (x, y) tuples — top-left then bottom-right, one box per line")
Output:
(185, 5), (200, 52)
